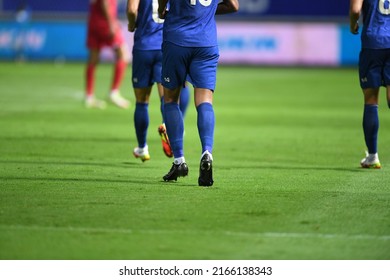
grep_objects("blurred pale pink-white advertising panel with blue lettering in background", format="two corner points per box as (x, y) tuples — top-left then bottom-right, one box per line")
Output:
(218, 22), (340, 66)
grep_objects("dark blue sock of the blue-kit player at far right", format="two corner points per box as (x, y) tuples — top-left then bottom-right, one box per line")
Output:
(363, 104), (379, 154)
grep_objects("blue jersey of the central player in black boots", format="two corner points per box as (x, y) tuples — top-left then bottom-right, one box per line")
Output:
(163, 0), (219, 47)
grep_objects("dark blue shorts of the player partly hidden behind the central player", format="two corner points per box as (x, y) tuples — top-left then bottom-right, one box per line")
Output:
(131, 50), (158, 88)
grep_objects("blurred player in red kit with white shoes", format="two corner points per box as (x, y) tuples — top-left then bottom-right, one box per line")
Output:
(85, 0), (130, 109)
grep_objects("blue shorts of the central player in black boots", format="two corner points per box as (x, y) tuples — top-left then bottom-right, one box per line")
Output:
(162, 42), (219, 91)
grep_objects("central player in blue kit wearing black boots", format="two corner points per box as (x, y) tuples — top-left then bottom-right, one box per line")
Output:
(158, 0), (239, 186)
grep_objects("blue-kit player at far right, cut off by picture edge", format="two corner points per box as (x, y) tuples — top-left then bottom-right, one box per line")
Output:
(349, 0), (390, 168)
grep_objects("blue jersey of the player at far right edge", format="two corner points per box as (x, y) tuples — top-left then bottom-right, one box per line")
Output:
(361, 0), (390, 49)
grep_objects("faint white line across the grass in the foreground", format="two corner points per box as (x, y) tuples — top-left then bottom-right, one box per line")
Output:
(0, 225), (390, 241)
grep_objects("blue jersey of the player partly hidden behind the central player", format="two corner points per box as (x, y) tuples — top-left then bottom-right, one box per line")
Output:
(133, 0), (164, 50)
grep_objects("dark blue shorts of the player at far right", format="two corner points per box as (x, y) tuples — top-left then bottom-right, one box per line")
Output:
(359, 49), (390, 89)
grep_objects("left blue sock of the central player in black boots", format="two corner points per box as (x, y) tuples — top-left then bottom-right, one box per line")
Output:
(164, 102), (184, 158)
